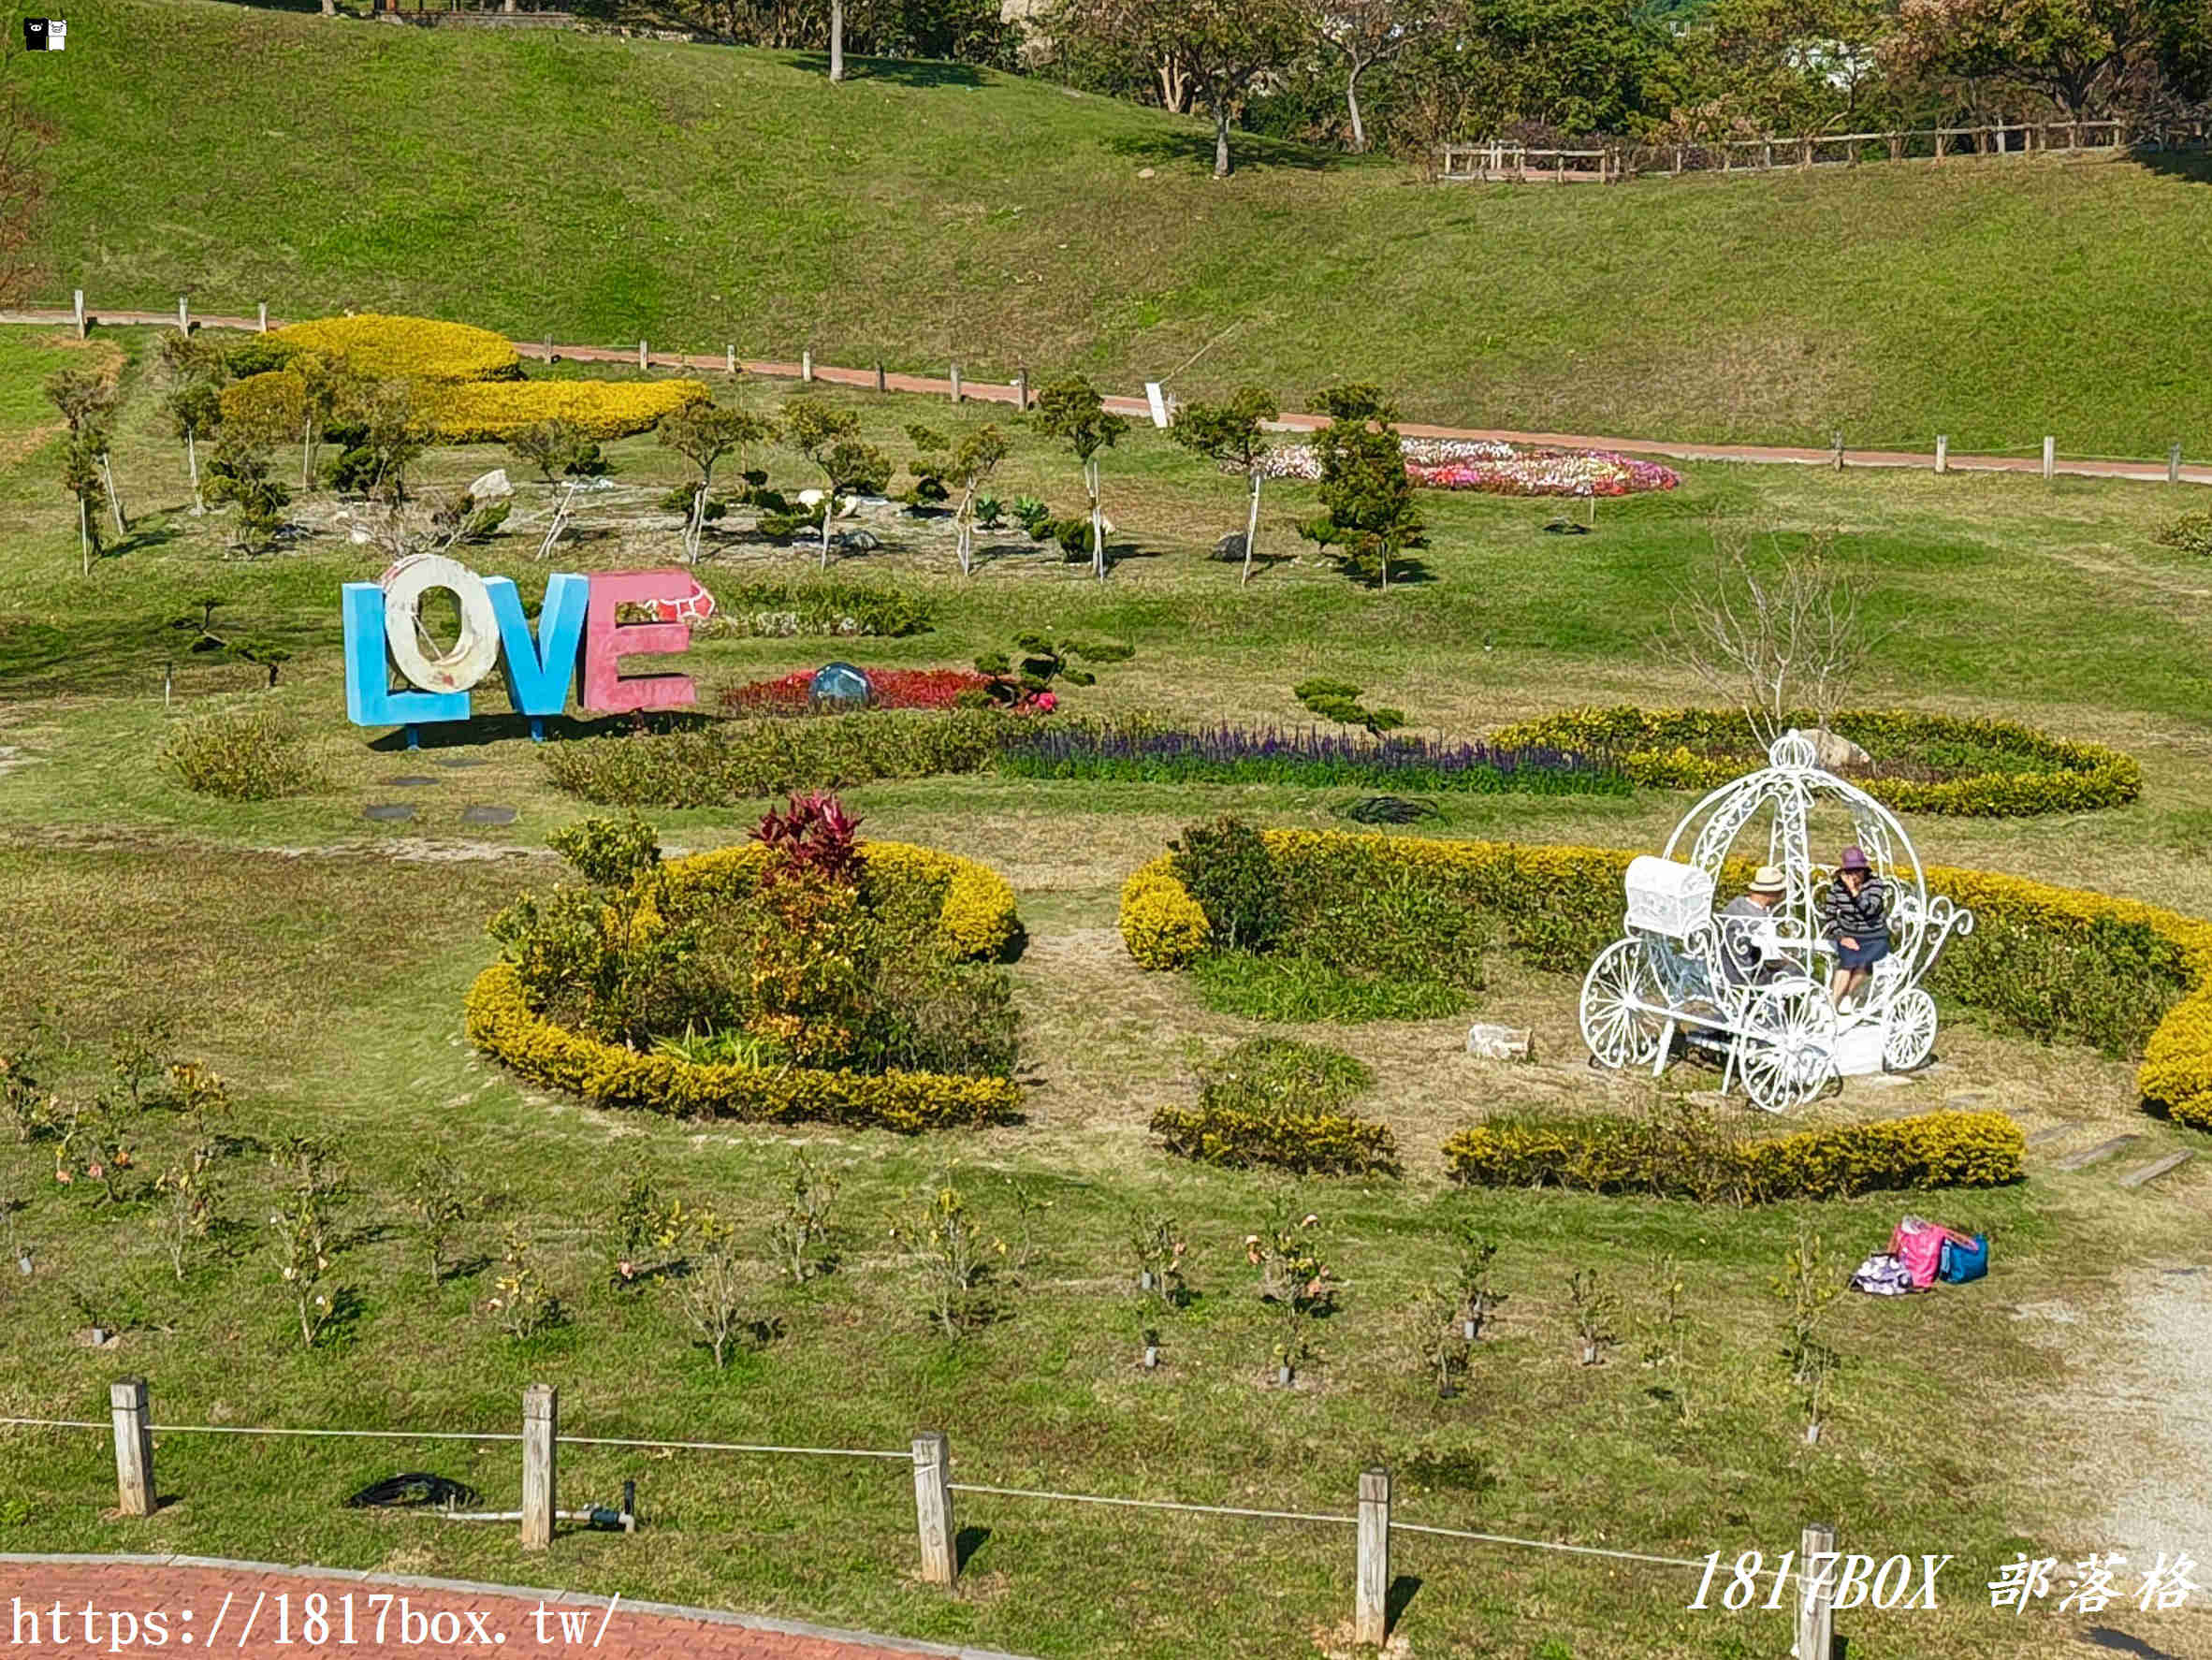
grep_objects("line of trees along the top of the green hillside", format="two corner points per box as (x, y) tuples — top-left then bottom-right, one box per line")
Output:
(557, 0), (2212, 175)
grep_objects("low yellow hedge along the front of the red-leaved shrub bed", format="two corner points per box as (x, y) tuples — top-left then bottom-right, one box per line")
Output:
(462, 963), (1022, 1133)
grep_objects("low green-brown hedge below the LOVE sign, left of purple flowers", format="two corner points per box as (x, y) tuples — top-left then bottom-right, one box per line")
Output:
(545, 710), (1007, 808)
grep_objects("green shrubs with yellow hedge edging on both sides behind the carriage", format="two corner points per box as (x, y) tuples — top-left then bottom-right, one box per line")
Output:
(1122, 830), (2212, 1131)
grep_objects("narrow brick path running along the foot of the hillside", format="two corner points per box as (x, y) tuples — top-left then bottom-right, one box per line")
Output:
(0, 310), (2212, 485)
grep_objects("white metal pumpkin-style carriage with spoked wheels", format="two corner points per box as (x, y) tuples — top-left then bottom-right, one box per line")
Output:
(1581, 733), (1973, 1114)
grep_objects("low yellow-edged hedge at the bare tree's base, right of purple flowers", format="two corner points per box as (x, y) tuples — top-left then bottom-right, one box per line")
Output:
(1491, 704), (2144, 819)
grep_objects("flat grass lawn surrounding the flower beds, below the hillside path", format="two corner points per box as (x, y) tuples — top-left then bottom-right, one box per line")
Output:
(0, 325), (2212, 1660)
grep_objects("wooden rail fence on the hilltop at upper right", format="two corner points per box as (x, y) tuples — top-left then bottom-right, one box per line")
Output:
(1435, 117), (2212, 183)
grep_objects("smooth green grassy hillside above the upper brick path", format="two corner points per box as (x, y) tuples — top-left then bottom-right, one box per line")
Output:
(18, 0), (2212, 456)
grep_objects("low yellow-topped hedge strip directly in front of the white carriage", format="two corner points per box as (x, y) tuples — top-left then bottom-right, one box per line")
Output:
(1445, 1114), (2026, 1204)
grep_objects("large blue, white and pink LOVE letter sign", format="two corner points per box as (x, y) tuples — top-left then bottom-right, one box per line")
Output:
(342, 553), (715, 737)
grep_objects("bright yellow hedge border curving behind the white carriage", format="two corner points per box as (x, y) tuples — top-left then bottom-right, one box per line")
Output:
(1122, 830), (2212, 1131)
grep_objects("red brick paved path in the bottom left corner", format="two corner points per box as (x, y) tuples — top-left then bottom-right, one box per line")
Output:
(0, 1556), (1013, 1660)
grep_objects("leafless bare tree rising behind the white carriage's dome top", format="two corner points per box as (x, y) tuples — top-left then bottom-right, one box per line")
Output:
(1654, 522), (1896, 744)
